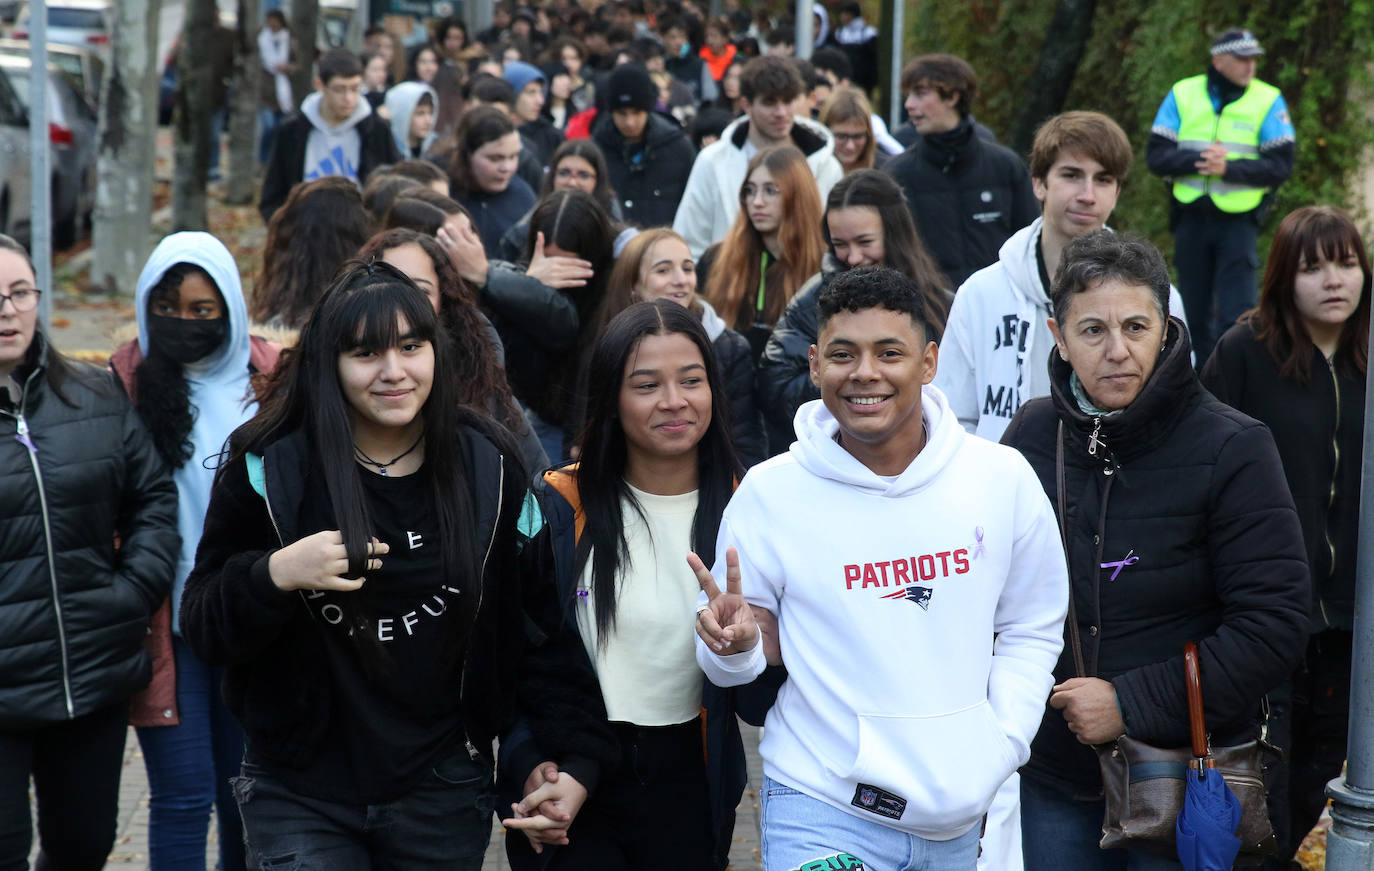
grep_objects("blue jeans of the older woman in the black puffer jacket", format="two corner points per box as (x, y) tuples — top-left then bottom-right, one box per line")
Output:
(1021, 778), (1183, 871)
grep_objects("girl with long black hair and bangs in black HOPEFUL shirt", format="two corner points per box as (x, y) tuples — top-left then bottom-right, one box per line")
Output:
(181, 262), (609, 870)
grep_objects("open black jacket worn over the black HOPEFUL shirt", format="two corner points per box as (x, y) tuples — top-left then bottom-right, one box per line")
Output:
(181, 426), (614, 783)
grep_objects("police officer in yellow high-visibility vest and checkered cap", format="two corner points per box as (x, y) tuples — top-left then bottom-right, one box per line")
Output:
(1146, 29), (1293, 365)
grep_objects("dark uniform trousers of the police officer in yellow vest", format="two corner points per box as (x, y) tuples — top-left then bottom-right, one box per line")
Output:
(1173, 210), (1260, 368)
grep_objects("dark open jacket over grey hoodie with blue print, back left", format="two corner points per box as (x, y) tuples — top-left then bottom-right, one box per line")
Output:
(258, 91), (401, 223)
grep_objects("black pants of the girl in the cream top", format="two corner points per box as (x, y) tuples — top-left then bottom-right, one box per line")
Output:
(506, 720), (716, 871)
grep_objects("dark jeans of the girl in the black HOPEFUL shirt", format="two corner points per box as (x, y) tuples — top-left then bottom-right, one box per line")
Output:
(234, 747), (495, 871)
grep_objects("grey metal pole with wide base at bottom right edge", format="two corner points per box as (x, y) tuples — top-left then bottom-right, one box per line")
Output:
(1326, 289), (1374, 871)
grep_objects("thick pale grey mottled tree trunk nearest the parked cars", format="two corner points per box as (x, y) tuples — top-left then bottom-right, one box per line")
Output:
(91, 0), (162, 294)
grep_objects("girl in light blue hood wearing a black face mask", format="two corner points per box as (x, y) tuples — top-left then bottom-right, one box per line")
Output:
(110, 232), (280, 871)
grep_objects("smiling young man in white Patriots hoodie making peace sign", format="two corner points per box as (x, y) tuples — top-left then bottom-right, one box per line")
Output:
(697, 267), (1068, 871)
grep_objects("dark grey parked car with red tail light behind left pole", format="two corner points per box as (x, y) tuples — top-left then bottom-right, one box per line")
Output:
(0, 55), (96, 247)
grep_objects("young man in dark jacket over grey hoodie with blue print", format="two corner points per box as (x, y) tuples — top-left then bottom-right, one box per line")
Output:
(258, 48), (401, 221)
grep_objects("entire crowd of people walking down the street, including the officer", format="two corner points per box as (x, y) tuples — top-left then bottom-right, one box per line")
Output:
(0, 0), (1371, 871)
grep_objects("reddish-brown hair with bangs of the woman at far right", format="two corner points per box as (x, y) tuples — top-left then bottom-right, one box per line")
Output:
(1241, 206), (1370, 385)
